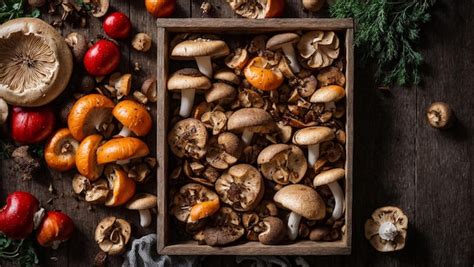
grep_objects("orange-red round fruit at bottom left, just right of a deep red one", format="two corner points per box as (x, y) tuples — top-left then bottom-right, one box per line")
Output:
(36, 211), (74, 247)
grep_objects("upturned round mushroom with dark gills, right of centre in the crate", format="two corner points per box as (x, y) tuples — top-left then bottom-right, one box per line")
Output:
(257, 144), (308, 185)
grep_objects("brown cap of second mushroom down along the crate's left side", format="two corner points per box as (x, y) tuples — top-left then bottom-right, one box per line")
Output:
(168, 68), (212, 90)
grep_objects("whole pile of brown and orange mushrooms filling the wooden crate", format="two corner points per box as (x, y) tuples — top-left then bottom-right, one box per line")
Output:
(167, 31), (346, 246)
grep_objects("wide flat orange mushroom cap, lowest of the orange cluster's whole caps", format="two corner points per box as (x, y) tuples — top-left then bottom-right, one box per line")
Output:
(97, 137), (150, 164)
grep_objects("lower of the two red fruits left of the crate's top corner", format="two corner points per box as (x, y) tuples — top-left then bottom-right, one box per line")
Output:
(84, 40), (120, 76)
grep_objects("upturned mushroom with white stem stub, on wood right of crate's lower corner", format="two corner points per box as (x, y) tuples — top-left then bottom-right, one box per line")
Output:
(365, 206), (408, 252)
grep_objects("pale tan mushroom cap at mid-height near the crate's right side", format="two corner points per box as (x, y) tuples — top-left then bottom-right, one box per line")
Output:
(293, 126), (335, 145)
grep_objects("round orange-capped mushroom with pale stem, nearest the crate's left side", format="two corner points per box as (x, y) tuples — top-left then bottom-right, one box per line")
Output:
(112, 100), (153, 137)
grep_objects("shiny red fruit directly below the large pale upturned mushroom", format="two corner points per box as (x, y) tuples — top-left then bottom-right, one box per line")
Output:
(10, 106), (55, 144)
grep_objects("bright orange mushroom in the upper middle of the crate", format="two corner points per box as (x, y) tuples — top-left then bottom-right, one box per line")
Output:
(244, 57), (285, 91)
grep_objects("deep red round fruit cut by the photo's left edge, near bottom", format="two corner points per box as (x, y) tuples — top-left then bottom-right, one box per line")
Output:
(0, 192), (39, 239)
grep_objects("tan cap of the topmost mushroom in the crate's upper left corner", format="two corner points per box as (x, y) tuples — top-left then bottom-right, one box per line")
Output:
(171, 38), (230, 60)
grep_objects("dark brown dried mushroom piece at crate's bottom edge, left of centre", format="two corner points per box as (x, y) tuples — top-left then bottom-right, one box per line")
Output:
(203, 207), (245, 246)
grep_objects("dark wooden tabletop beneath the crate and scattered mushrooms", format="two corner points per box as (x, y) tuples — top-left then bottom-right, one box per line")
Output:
(0, 0), (474, 266)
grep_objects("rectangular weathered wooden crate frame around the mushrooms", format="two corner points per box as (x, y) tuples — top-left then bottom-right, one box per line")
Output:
(156, 19), (354, 255)
